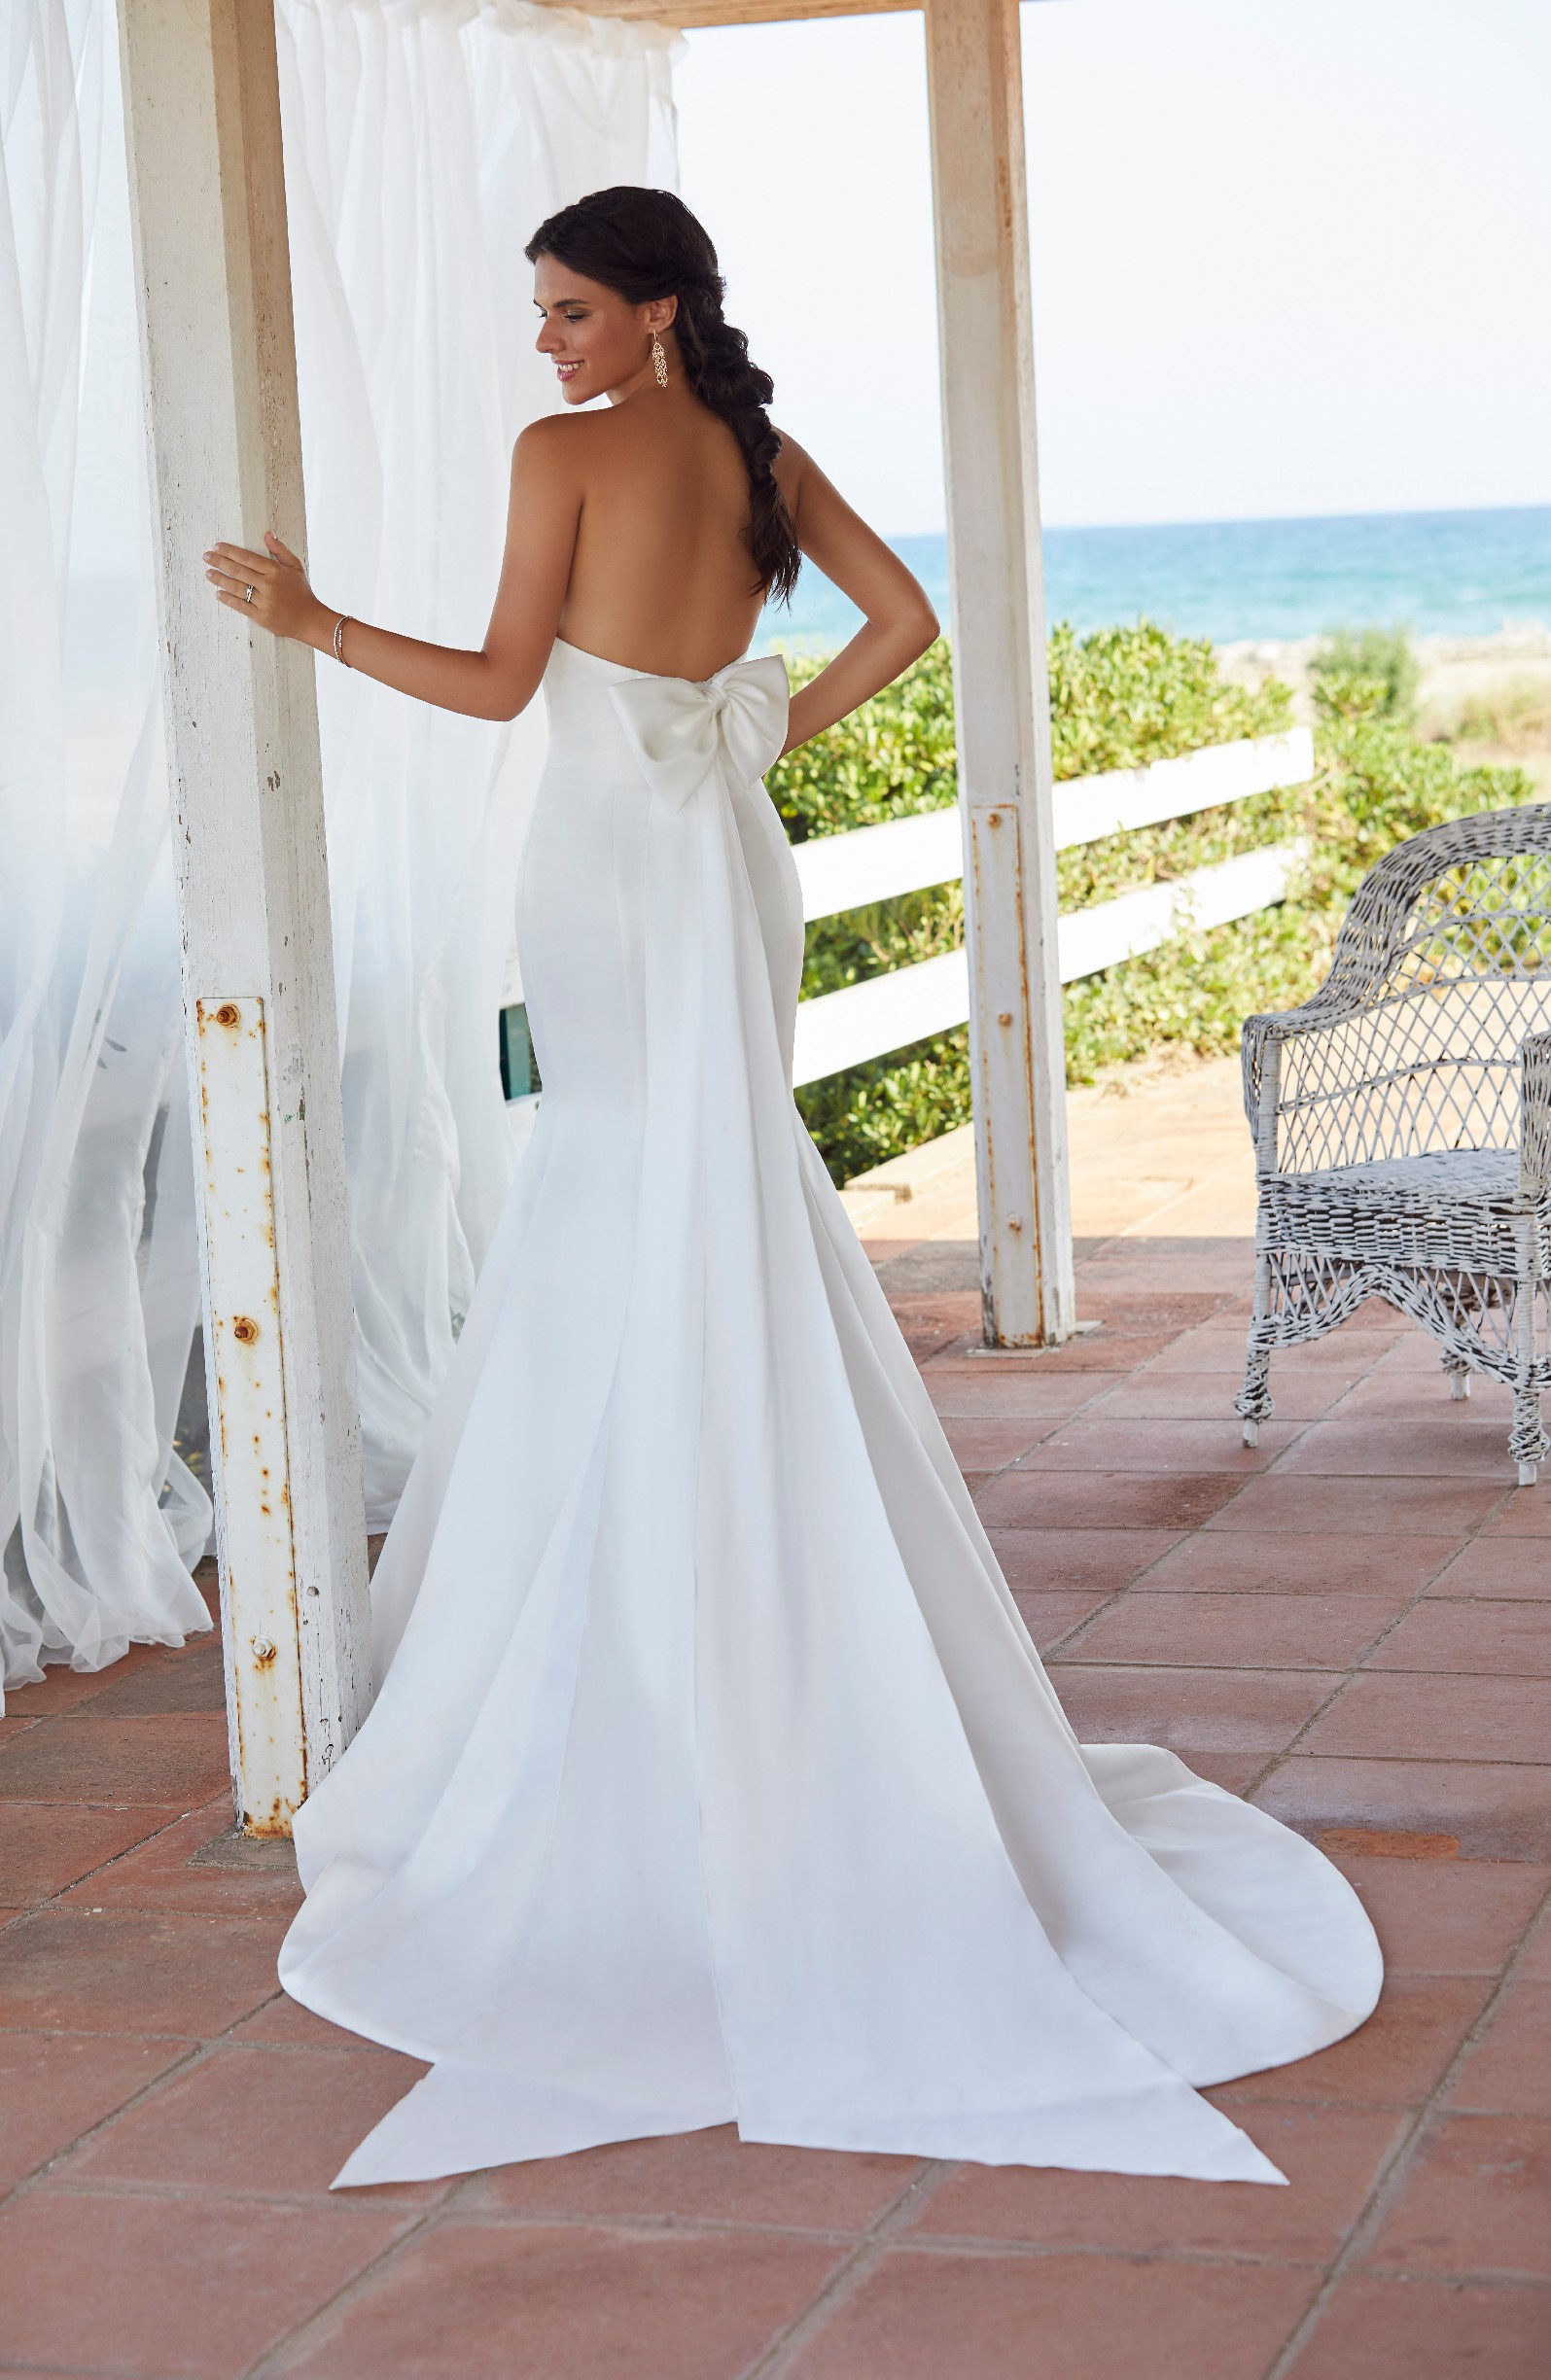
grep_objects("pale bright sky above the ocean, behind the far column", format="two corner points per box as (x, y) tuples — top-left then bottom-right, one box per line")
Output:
(676, 0), (1551, 536)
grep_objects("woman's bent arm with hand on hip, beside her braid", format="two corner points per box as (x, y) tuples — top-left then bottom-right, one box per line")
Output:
(776, 438), (937, 752)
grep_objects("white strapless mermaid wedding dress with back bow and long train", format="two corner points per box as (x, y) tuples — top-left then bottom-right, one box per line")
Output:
(281, 643), (1380, 2183)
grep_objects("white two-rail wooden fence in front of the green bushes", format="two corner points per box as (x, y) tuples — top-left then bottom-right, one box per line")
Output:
(793, 728), (1313, 1083)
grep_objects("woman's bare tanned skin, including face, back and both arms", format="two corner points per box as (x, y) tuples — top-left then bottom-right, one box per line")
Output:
(204, 234), (937, 750)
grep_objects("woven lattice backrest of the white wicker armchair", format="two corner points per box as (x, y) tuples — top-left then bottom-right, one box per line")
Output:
(1278, 802), (1551, 1173)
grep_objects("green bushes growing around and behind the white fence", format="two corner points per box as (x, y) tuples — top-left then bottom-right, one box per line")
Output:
(790, 623), (1532, 1180)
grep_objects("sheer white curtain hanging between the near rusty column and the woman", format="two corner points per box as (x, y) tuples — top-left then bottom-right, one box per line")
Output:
(276, 0), (676, 1528)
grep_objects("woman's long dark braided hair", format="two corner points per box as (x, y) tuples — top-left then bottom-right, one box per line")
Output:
(523, 183), (801, 602)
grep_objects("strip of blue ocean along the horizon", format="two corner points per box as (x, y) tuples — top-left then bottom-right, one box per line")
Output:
(761, 505), (1551, 649)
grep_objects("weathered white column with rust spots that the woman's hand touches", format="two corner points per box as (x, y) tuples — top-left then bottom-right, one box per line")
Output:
(119, 0), (369, 1835)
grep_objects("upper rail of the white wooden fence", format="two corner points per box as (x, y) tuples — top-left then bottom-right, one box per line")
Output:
(794, 728), (1313, 918)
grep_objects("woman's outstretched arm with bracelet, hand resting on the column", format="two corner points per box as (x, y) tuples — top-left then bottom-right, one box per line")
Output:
(204, 416), (581, 718)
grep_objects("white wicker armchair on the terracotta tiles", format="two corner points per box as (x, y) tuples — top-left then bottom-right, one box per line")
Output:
(1235, 802), (1551, 1486)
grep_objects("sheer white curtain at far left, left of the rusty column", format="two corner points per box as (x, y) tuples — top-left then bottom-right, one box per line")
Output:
(0, 0), (209, 1680)
